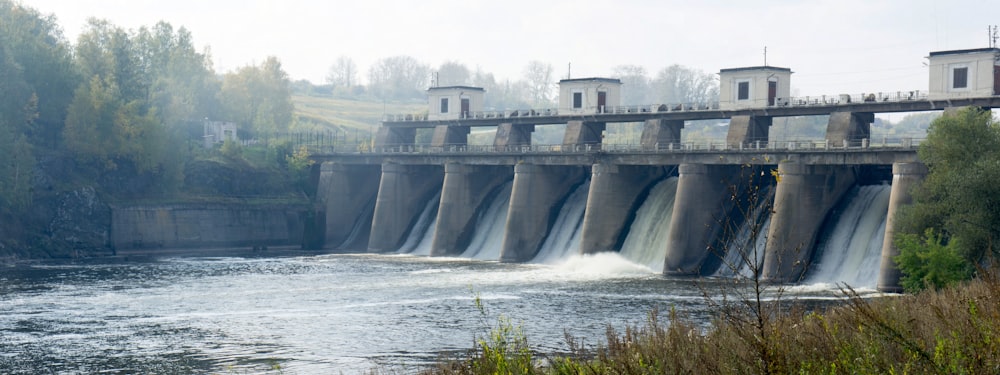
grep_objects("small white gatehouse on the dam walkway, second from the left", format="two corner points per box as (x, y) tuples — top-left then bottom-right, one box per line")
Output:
(559, 78), (622, 114)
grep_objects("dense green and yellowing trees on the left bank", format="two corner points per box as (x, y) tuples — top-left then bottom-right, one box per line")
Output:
(0, 0), (293, 215)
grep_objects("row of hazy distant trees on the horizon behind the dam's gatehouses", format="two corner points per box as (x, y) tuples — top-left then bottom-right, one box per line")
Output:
(326, 56), (719, 110)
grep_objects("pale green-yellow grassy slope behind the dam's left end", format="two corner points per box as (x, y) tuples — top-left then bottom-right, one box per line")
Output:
(292, 94), (427, 131)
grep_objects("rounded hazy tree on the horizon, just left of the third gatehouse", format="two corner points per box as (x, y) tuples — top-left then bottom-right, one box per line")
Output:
(653, 65), (719, 104)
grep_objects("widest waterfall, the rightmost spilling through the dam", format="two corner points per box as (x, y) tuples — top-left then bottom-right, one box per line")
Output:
(806, 185), (891, 287)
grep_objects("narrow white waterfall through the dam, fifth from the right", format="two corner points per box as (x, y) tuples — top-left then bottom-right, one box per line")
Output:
(462, 181), (514, 260)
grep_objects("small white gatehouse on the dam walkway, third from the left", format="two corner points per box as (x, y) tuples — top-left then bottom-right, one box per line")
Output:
(719, 66), (792, 109)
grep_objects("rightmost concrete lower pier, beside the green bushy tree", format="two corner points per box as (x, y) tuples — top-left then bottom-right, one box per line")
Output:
(877, 163), (927, 293)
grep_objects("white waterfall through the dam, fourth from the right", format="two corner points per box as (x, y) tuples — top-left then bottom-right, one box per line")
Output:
(531, 179), (590, 264)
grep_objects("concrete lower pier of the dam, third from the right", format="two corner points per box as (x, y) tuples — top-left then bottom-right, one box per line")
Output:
(663, 164), (738, 276)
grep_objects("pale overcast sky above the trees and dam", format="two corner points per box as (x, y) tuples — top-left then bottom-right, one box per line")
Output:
(22, 0), (1000, 96)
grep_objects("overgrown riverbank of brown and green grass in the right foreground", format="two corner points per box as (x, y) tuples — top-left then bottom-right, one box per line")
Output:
(426, 275), (1000, 374)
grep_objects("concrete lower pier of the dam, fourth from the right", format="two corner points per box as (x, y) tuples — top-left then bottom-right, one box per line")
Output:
(580, 164), (667, 254)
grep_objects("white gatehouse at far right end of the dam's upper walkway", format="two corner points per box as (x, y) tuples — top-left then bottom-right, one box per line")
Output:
(927, 48), (1000, 100)
